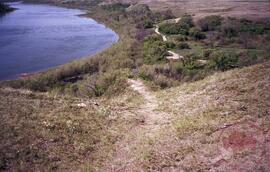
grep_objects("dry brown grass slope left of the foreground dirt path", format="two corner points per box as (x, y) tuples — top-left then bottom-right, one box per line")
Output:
(0, 89), (121, 171)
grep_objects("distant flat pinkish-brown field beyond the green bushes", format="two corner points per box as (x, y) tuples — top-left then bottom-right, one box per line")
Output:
(113, 0), (270, 19)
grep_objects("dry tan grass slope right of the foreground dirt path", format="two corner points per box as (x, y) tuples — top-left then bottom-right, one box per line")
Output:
(139, 63), (270, 171)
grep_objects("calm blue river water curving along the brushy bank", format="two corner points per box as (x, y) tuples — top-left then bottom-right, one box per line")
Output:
(0, 3), (118, 80)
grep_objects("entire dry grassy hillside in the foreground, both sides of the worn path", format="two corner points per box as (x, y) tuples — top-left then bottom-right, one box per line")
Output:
(0, 63), (270, 171)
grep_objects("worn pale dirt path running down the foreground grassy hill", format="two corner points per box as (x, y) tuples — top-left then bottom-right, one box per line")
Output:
(102, 79), (169, 172)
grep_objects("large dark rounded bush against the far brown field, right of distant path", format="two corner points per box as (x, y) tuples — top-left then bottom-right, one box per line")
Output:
(198, 15), (222, 31)
